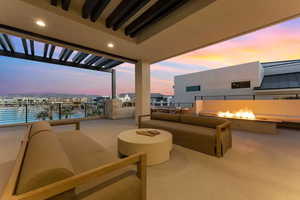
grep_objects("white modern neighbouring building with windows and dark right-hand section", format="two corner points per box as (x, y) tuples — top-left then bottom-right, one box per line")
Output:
(174, 60), (300, 103)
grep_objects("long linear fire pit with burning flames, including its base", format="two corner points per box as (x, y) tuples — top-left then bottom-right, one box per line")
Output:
(199, 111), (282, 134)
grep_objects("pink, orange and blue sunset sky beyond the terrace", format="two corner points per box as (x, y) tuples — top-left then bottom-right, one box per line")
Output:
(0, 18), (300, 95)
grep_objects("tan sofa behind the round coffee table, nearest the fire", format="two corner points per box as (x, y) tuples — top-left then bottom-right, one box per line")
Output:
(139, 112), (232, 157)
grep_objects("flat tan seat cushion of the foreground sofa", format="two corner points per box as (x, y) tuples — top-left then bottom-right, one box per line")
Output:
(56, 131), (140, 200)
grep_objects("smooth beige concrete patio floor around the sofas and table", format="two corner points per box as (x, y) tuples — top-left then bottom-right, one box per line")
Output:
(0, 120), (300, 200)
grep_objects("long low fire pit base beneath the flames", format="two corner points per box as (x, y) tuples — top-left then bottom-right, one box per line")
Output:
(199, 113), (280, 134)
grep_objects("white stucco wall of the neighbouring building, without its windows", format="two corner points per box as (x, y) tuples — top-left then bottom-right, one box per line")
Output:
(174, 62), (264, 103)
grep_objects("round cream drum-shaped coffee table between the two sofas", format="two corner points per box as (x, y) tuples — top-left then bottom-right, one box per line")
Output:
(118, 129), (172, 165)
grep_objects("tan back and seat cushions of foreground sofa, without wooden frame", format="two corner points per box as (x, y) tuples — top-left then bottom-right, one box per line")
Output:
(16, 122), (142, 200)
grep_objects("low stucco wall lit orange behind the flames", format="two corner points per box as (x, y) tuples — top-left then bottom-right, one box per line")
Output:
(195, 100), (300, 118)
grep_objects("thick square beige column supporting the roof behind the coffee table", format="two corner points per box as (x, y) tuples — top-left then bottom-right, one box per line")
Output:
(135, 61), (150, 119)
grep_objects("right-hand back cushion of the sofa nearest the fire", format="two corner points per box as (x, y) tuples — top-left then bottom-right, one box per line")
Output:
(181, 115), (226, 128)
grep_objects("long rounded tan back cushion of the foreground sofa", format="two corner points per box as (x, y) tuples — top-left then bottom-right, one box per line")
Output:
(16, 131), (75, 200)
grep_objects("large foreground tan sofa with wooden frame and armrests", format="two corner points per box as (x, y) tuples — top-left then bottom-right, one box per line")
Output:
(2, 122), (146, 200)
